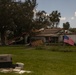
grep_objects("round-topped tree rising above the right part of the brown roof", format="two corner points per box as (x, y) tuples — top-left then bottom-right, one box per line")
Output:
(49, 10), (61, 27)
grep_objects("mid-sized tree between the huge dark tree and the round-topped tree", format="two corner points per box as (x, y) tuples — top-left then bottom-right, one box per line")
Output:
(34, 10), (49, 29)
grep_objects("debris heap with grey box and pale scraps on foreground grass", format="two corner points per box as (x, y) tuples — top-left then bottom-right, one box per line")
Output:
(0, 54), (31, 74)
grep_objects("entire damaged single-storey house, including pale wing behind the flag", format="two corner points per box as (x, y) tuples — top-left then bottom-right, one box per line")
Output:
(32, 28), (76, 43)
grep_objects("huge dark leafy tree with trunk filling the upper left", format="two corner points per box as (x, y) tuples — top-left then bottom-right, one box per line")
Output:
(0, 0), (36, 45)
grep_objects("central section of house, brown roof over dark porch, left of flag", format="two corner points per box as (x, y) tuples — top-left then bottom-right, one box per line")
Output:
(32, 28), (61, 43)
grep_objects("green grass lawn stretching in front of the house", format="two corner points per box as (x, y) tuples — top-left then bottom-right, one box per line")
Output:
(0, 46), (76, 75)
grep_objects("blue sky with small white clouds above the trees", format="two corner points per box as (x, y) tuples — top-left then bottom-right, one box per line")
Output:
(36, 0), (76, 28)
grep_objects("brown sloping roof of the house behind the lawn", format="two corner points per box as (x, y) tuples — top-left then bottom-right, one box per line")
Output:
(37, 28), (61, 37)
